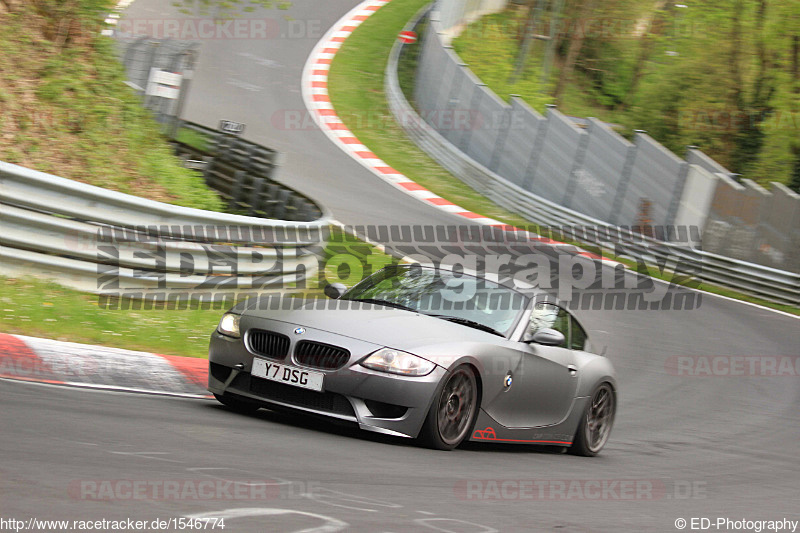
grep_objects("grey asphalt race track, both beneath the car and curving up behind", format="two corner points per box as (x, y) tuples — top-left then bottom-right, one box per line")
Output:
(0, 0), (800, 533)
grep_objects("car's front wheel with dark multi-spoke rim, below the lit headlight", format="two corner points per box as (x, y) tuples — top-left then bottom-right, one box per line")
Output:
(420, 365), (478, 450)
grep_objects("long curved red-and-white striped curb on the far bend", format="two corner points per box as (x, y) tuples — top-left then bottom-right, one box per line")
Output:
(302, 0), (618, 265)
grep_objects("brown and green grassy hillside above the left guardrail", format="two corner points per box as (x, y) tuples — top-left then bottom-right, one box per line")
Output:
(0, 0), (223, 211)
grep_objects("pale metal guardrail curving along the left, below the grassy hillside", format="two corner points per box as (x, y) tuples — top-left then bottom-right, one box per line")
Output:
(0, 158), (330, 300)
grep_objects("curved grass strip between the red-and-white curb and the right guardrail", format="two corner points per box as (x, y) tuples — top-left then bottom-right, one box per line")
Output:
(328, 0), (800, 315)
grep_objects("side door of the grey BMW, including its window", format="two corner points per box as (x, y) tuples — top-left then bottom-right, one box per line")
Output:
(486, 302), (578, 428)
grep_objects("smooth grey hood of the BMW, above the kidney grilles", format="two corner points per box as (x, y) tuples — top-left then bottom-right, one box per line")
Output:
(243, 304), (503, 353)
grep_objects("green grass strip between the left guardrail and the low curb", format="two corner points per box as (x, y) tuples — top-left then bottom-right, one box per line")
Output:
(0, 235), (397, 357)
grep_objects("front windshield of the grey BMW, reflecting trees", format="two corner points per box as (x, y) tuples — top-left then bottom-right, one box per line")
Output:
(342, 265), (528, 336)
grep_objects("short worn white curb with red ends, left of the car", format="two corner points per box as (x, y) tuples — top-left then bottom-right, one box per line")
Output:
(0, 333), (210, 398)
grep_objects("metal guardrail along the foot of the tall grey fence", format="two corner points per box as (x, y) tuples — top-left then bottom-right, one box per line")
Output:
(384, 6), (800, 306)
